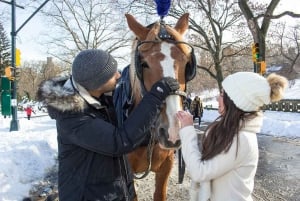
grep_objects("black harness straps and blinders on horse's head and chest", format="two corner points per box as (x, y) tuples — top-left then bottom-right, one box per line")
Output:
(134, 21), (197, 179)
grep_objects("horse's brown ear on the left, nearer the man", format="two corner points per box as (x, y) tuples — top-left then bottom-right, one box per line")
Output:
(125, 14), (149, 40)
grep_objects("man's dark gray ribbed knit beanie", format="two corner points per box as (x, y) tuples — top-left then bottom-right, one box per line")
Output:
(72, 49), (118, 90)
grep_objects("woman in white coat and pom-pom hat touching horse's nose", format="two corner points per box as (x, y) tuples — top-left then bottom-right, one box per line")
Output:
(177, 72), (287, 201)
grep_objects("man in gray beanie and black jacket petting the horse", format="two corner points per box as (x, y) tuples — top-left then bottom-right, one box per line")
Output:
(38, 49), (179, 201)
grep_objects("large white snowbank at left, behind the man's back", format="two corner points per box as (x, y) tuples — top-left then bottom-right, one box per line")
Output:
(0, 112), (57, 201)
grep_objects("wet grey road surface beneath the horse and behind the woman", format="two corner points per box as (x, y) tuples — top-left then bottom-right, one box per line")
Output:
(25, 122), (300, 201)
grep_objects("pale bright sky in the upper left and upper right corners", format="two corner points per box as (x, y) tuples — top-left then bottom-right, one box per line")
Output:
(0, 0), (300, 62)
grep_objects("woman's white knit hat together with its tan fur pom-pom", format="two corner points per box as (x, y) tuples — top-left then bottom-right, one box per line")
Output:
(222, 72), (287, 112)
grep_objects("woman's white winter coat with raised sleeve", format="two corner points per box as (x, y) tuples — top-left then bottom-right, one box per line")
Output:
(180, 112), (263, 201)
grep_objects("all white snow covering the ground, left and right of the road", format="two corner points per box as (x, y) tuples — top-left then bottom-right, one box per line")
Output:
(0, 80), (300, 201)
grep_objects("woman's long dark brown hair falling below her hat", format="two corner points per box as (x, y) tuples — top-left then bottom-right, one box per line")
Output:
(202, 91), (256, 160)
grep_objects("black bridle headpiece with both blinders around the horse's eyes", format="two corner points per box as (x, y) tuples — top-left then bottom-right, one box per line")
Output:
(135, 23), (197, 82)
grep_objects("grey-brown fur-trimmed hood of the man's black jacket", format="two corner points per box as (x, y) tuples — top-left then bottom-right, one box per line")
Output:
(37, 77), (86, 116)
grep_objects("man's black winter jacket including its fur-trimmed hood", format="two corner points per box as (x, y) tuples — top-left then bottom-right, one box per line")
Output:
(38, 78), (162, 201)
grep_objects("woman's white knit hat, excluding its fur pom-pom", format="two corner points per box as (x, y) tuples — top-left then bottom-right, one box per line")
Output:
(222, 72), (271, 112)
